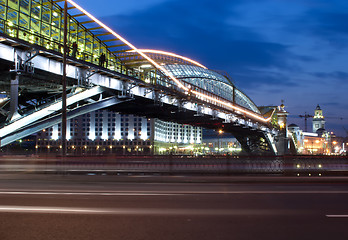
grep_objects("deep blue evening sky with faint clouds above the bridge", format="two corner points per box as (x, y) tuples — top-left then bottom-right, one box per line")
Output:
(76, 0), (348, 136)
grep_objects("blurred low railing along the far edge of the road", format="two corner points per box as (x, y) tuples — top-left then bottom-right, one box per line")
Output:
(0, 155), (348, 177)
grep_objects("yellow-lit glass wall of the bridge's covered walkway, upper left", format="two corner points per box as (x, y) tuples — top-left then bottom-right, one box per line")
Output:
(0, 0), (128, 76)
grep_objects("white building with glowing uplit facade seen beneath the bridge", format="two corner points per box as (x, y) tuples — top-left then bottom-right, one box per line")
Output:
(36, 110), (202, 154)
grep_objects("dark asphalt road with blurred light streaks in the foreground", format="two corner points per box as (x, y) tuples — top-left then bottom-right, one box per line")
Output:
(0, 175), (348, 240)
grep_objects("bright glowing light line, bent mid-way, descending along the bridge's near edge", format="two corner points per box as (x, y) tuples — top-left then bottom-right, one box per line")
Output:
(67, 0), (271, 122)
